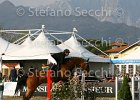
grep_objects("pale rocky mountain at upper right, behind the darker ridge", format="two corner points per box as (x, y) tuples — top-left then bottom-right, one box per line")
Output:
(50, 0), (140, 27)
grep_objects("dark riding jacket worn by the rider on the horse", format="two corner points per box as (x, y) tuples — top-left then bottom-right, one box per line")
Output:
(52, 52), (65, 66)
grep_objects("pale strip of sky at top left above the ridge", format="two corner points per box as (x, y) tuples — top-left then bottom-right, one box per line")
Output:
(0, 0), (59, 7)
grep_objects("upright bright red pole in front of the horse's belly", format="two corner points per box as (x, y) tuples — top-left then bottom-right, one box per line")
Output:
(47, 69), (52, 100)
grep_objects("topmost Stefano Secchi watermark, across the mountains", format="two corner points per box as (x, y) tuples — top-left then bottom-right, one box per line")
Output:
(16, 7), (124, 17)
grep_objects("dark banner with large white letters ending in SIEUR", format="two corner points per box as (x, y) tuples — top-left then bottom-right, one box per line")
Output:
(20, 82), (115, 97)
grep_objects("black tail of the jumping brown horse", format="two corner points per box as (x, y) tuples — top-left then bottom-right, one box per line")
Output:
(15, 74), (28, 94)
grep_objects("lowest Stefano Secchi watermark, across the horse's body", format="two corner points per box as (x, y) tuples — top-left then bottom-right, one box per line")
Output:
(18, 68), (120, 78)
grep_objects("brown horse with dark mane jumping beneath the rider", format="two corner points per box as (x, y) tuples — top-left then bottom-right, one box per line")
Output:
(15, 57), (89, 100)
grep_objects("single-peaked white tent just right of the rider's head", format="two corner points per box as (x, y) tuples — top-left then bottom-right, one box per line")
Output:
(58, 36), (110, 62)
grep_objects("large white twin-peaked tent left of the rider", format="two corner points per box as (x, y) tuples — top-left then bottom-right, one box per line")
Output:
(2, 32), (61, 63)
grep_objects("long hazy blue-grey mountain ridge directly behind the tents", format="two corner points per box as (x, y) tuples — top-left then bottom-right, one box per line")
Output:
(0, 1), (140, 43)
